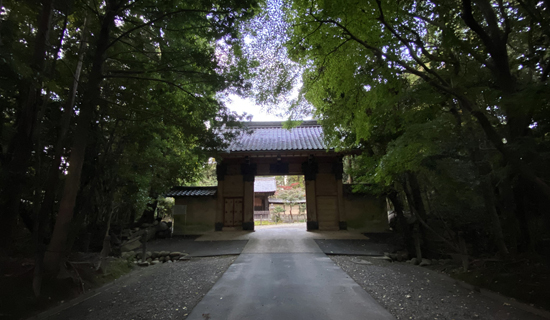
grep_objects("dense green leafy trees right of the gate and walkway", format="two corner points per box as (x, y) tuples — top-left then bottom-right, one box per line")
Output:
(286, 0), (550, 254)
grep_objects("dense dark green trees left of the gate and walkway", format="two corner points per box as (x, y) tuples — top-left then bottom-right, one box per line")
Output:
(0, 0), (257, 278)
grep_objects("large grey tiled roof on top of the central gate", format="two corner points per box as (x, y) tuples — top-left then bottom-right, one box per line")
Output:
(227, 121), (327, 152)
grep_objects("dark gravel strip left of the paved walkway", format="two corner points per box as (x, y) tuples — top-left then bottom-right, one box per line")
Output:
(48, 256), (236, 320)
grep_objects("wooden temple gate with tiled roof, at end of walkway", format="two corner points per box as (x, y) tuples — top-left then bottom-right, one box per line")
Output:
(215, 121), (347, 230)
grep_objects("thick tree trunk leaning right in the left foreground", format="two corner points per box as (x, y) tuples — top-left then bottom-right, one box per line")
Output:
(44, 1), (118, 273)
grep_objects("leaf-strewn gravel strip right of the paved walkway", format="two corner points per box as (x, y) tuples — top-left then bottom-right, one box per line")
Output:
(330, 256), (543, 320)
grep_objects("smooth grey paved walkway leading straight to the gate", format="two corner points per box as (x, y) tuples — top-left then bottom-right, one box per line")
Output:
(188, 226), (394, 320)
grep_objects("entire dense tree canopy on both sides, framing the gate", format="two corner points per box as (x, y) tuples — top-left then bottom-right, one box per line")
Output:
(0, 0), (550, 296)
